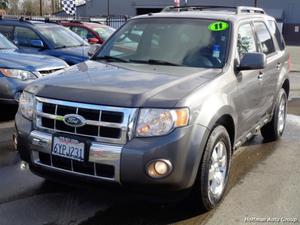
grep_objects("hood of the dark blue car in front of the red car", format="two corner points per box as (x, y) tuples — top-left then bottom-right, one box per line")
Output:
(48, 45), (94, 65)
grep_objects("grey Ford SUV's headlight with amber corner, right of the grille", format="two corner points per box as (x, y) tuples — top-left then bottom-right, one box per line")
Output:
(136, 108), (189, 137)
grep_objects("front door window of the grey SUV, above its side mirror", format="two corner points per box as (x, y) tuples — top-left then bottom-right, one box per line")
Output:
(237, 24), (257, 57)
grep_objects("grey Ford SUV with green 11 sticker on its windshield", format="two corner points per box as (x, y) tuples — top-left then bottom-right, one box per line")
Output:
(16, 6), (289, 210)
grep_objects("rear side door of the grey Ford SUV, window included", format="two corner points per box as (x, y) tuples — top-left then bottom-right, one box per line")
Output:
(254, 21), (282, 116)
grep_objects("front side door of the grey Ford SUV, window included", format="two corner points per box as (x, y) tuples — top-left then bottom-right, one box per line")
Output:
(236, 22), (262, 136)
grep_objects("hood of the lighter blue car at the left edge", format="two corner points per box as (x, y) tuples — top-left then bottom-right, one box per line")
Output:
(0, 49), (67, 71)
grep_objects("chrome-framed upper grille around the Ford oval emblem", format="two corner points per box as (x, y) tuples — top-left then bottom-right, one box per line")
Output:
(36, 97), (137, 144)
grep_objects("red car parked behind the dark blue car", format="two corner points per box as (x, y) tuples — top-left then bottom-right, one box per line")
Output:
(60, 21), (115, 44)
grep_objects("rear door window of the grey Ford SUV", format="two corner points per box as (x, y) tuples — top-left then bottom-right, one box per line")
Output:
(254, 22), (275, 55)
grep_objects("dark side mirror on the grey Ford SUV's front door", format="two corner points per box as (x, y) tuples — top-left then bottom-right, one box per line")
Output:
(237, 52), (267, 71)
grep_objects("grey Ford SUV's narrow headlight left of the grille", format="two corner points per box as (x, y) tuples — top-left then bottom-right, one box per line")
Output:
(19, 91), (36, 120)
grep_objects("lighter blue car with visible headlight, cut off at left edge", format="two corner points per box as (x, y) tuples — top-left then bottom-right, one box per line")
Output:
(0, 34), (68, 104)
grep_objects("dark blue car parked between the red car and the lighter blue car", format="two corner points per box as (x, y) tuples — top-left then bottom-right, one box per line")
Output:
(0, 19), (95, 65)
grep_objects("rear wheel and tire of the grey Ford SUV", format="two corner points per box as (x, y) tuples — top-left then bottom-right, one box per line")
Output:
(261, 89), (288, 141)
